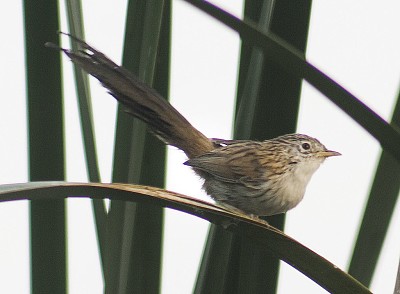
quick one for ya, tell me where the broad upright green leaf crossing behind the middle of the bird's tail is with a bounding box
[106,0,170,293]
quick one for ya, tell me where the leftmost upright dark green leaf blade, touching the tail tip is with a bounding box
[24,0,67,293]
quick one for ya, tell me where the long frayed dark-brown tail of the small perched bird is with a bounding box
[46,34,214,158]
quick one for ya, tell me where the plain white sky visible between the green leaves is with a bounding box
[0,0,400,293]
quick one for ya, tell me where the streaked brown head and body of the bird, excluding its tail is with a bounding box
[185,134,339,216]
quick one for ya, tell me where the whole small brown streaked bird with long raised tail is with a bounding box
[46,33,341,218]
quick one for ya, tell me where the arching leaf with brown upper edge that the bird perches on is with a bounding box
[0,182,371,293]
